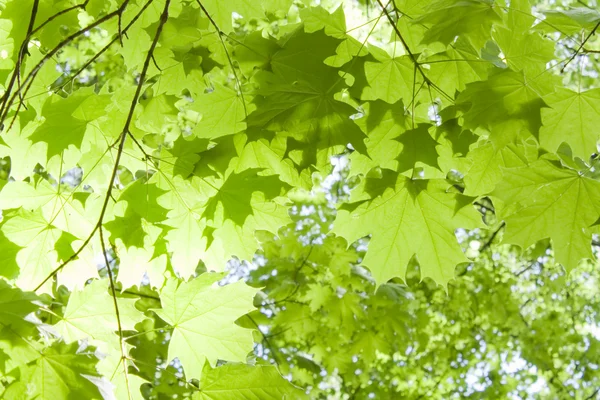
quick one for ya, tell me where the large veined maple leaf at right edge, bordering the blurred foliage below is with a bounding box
[493,160,600,270]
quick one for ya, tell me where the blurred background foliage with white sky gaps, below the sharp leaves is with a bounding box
[244,196,600,399]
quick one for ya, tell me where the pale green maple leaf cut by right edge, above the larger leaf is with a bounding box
[540,88,600,160]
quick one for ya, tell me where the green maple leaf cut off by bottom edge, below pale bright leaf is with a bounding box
[192,363,307,400]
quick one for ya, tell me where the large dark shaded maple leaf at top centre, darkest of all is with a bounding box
[248,30,366,168]
